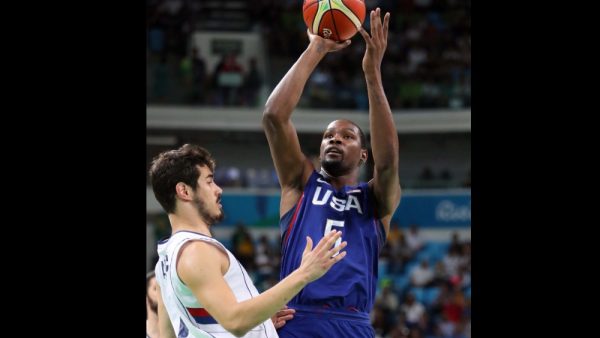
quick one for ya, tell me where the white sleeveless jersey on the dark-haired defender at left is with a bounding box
[155,231,279,338]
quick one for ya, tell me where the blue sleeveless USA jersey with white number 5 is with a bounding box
[280,171,385,316]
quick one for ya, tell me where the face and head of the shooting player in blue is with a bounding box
[320,120,366,176]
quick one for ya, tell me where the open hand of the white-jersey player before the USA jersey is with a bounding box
[298,230,348,282]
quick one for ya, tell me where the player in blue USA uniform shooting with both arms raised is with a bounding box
[263,8,400,338]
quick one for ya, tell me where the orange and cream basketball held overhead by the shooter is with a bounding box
[302,0,366,42]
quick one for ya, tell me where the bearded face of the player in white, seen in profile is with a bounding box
[194,166,225,224]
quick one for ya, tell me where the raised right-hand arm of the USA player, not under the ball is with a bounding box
[360,8,400,234]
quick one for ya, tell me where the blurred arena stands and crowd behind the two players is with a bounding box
[146,0,471,337]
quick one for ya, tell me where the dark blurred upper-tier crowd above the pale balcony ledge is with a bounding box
[147,0,471,110]
